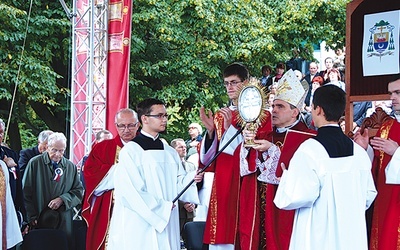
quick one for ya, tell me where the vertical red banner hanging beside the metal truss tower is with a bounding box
[106,0,132,135]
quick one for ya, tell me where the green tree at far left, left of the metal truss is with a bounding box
[0,0,71,150]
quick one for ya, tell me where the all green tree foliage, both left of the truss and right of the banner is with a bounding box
[0,0,348,149]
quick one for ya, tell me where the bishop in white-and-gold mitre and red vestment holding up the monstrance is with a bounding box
[244,70,316,250]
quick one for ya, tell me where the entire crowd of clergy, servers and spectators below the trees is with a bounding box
[0,55,400,250]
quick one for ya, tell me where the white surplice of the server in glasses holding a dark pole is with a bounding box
[107,142,199,250]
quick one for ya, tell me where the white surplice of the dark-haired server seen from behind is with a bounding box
[274,139,377,250]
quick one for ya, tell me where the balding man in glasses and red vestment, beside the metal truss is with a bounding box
[82,109,139,249]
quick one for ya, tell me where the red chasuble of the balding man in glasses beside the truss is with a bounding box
[82,135,123,250]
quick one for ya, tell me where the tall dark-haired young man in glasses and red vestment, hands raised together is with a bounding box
[200,63,271,250]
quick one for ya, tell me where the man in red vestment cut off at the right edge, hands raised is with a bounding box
[354,79,400,250]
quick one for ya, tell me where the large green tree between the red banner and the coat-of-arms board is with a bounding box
[126,0,348,143]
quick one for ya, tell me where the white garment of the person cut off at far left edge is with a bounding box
[0,160,22,249]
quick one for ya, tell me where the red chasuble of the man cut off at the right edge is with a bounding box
[370,119,400,250]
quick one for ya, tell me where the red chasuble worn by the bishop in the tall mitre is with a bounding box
[261,122,315,250]
